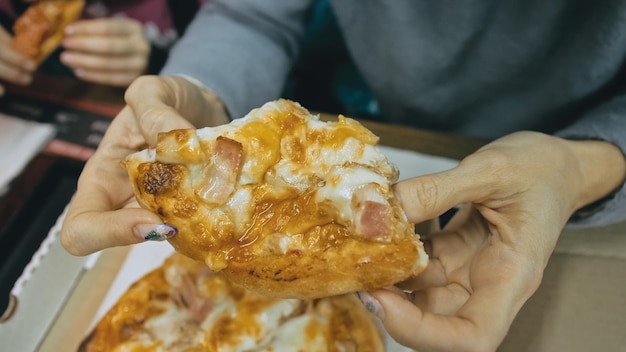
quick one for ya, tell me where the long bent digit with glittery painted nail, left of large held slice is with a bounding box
[61,107,178,255]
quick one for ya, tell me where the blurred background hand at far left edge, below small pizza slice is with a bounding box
[0,26,36,95]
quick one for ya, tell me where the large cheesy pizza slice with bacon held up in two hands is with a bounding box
[122,100,427,298]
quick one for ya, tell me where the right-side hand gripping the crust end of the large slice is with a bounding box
[360,132,626,351]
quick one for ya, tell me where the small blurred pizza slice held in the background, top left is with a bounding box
[12,0,85,64]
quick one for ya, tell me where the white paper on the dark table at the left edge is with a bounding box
[0,113,55,196]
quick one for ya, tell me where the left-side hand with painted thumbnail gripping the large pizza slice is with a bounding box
[61,76,228,255]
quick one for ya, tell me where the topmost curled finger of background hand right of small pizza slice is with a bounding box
[65,18,143,37]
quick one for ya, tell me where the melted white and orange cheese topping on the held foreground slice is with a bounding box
[127,101,397,253]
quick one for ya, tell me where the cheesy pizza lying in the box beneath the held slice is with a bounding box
[79,254,384,352]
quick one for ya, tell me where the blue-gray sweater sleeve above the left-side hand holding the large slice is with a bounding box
[161,0,312,118]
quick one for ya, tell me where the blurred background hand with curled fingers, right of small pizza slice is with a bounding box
[61,18,150,87]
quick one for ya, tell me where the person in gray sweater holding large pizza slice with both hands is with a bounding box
[62,0,626,351]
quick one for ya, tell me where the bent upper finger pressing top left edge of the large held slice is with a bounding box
[124,76,194,145]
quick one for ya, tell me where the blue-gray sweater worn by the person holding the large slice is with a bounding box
[162,0,626,226]
